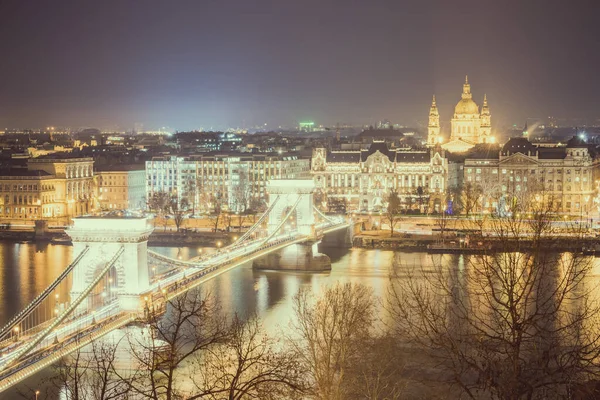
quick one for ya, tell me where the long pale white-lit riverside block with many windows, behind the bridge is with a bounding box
[146,153,310,211]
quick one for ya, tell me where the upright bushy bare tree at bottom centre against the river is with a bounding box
[288,283,375,400]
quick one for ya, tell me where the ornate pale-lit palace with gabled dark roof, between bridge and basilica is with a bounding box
[311,140,448,211]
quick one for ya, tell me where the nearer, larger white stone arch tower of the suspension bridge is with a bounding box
[67,217,153,311]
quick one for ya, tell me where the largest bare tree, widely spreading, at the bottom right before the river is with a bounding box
[389,211,600,400]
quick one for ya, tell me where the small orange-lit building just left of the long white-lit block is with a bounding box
[95,165,146,211]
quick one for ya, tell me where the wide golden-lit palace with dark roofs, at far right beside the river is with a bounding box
[464,137,598,216]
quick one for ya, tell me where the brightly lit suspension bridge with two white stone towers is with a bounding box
[0,179,352,392]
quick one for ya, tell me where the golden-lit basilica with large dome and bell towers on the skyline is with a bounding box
[434,78,494,153]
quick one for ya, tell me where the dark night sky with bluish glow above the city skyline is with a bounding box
[0,0,600,130]
